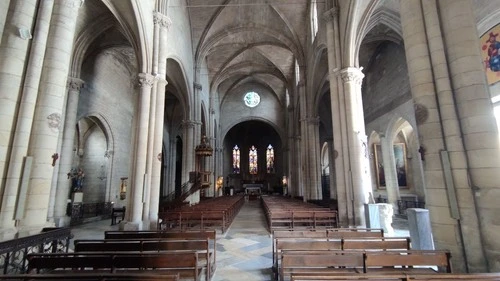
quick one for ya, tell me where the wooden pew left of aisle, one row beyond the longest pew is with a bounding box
[74,238,215,281]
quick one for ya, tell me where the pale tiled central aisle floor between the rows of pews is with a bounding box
[212,200,272,281]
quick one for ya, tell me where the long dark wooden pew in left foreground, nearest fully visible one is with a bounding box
[27,252,202,281]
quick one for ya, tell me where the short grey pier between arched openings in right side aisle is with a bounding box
[379,134,400,210]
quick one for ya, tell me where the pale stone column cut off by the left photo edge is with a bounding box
[0,0,37,208]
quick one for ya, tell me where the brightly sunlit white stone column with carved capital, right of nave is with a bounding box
[340,67,371,225]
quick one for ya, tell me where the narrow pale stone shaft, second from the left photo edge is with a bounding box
[0,0,54,232]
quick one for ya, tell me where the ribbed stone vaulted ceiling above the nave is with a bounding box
[187,0,309,104]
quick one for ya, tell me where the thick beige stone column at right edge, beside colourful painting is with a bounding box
[437,0,500,272]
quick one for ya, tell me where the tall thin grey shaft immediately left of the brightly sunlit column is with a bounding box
[323,7,354,226]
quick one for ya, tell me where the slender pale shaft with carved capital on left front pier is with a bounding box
[127,73,155,229]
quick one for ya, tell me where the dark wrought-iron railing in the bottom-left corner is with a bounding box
[0,228,73,274]
